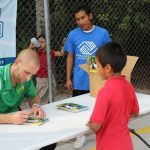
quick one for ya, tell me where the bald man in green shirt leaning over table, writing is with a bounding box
[0,49,45,124]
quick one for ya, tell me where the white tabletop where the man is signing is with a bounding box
[0,94,150,150]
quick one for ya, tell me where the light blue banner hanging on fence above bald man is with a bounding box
[0,0,17,65]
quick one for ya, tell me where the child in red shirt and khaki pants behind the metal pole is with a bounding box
[36,34,65,104]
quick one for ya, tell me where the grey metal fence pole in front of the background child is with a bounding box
[44,0,52,103]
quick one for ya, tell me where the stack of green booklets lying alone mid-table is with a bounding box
[56,103,88,112]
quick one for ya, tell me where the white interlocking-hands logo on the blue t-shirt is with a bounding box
[78,41,97,55]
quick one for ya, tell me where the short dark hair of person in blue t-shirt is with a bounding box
[73,4,92,15]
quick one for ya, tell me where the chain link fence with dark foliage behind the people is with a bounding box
[17,0,150,99]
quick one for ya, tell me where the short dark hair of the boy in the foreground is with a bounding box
[96,42,127,73]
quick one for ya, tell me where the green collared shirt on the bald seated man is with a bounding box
[0,64,36,113]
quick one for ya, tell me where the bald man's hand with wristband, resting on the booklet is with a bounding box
[30,104,45,118]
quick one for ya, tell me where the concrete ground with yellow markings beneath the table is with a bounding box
[56,114,150,150]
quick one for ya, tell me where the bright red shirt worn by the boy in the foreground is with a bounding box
[90,76,139,150]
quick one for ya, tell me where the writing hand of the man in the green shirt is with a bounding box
[12,111,29,124]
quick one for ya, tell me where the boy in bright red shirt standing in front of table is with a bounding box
[87,42,139,150]
